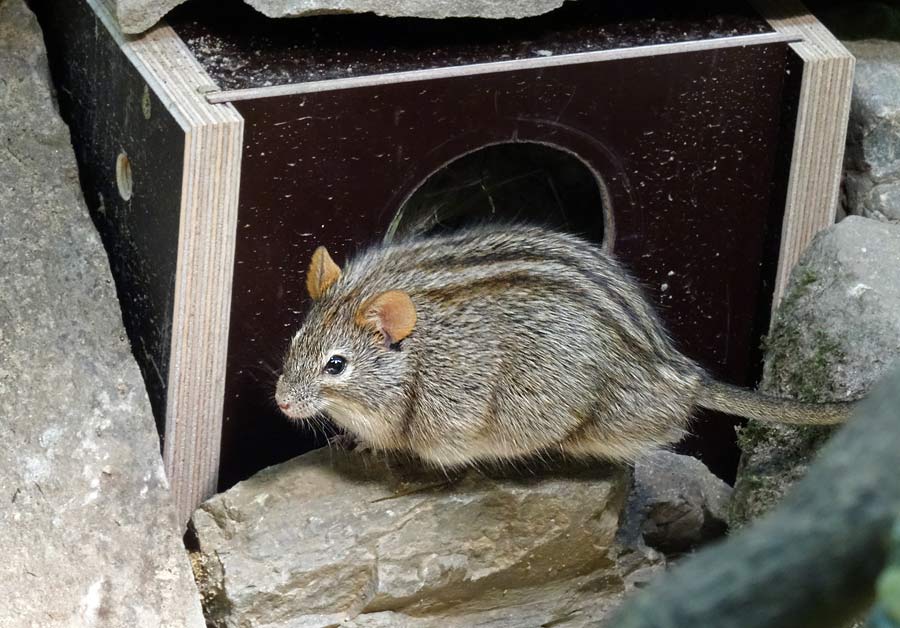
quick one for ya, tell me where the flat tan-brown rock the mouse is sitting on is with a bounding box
[192,450,654,628]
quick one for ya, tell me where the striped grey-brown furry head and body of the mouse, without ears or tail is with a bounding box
[276,227,702,466]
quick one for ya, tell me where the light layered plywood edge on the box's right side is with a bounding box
[754,0,856,308]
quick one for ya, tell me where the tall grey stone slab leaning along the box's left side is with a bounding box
[0,0,204,628]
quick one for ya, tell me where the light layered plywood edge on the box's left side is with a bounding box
[87,0,244,524]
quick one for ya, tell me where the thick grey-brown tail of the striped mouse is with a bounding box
[697,379,856,425]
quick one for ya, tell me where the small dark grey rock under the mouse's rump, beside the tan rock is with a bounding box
[623,451,731,554]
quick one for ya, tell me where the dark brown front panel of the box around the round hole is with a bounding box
[221,44,794,488]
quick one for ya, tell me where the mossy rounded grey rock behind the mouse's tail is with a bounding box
[731,216,900,525]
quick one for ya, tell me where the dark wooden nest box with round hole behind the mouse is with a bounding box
[43,0,853,521]
